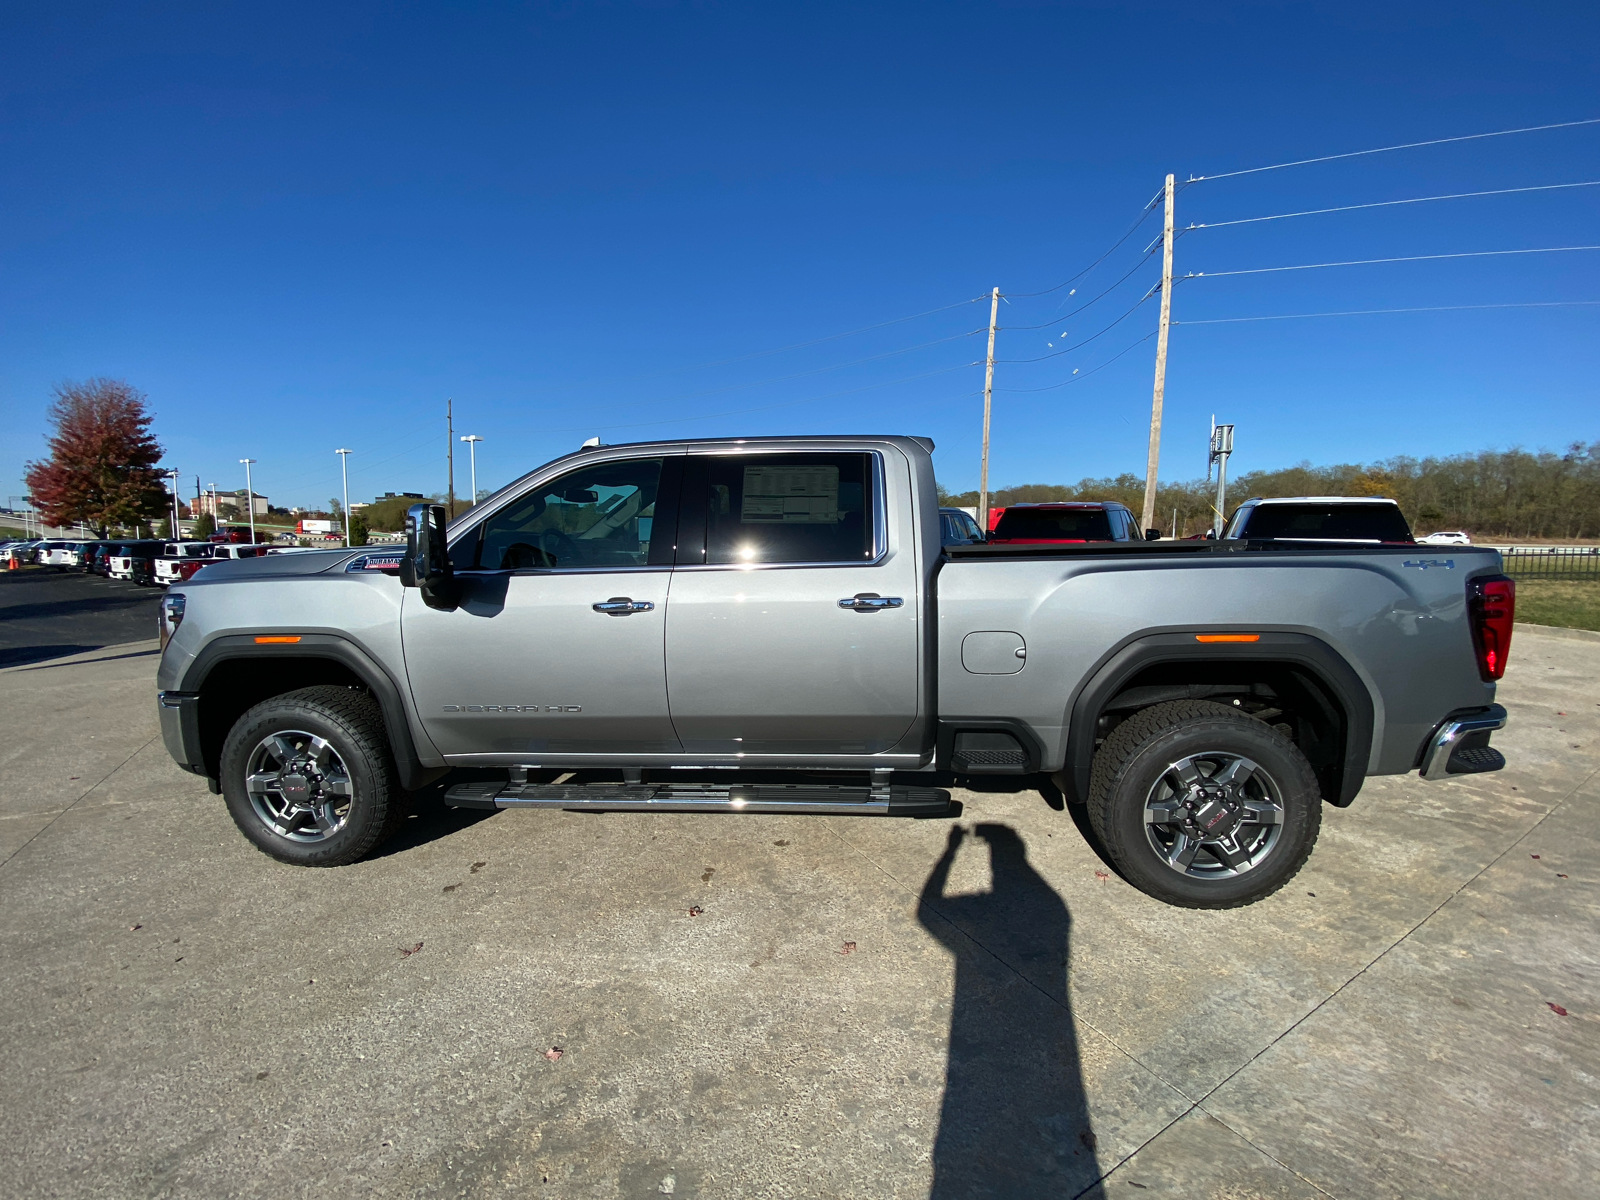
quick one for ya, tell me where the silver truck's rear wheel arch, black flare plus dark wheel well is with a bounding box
[1058,627,1374,808]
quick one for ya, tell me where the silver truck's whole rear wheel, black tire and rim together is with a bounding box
[1088,701,1322,909]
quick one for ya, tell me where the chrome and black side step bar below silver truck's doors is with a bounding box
[445,782,950,816]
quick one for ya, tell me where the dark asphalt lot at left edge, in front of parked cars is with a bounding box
[0,566,162,667]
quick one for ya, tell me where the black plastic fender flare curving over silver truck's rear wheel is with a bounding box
[1061,626,1376,808]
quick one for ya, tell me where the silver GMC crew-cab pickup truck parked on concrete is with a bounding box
[158,437,1514,907]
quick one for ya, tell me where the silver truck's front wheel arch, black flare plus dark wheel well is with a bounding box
[179,634,448,790]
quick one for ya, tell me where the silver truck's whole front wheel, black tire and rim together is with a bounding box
[222,685,405,867]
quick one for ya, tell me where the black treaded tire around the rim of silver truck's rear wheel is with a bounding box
[1088,701,1322,909]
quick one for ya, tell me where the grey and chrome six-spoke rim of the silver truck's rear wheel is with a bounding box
[1144,750,1283,880]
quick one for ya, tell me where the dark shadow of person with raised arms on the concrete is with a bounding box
[917,824,1104,1200]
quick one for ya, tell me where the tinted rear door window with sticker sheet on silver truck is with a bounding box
[678,453,877,565]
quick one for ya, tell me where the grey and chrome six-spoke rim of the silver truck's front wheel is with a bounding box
[245,730,355,842]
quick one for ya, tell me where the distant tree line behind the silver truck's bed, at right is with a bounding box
[939,442,1600,538]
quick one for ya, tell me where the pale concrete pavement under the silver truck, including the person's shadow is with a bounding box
[0,632,1600,1200]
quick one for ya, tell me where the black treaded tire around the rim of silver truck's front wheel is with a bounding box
[221,685,406,867]
